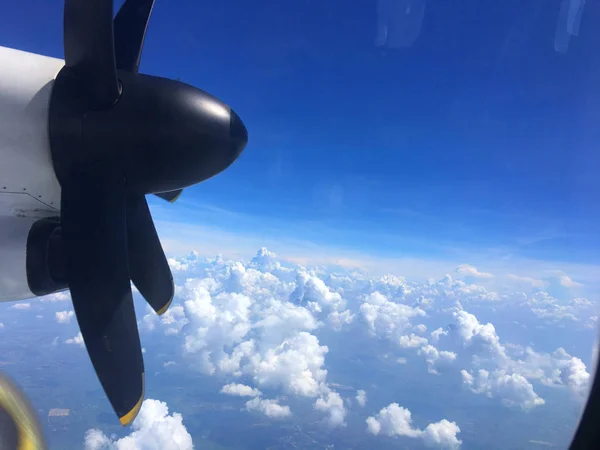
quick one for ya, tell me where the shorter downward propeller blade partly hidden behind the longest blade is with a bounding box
[127,195,175,315]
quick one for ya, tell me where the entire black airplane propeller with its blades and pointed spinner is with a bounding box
[49,0,248,425]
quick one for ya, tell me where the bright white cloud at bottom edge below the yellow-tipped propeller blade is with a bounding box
[85,399,194,450]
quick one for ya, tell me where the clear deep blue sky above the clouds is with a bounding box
[0,0,600,263]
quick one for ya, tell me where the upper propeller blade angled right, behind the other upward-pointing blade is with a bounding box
[114,0,154,72]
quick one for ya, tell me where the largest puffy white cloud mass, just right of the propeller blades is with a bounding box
[140,253,342,424]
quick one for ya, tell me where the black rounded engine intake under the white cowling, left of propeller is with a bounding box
[26,217,68,296]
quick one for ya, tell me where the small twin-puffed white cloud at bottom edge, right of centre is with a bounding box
[366,403,462,449]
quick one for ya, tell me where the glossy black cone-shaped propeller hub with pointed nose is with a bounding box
[50,69,248,194]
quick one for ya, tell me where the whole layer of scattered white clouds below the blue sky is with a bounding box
[52,248,596,449]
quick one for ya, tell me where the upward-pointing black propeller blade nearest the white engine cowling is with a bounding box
[63,0,121,108]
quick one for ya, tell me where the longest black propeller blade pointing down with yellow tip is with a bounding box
[61,170,144,425]
